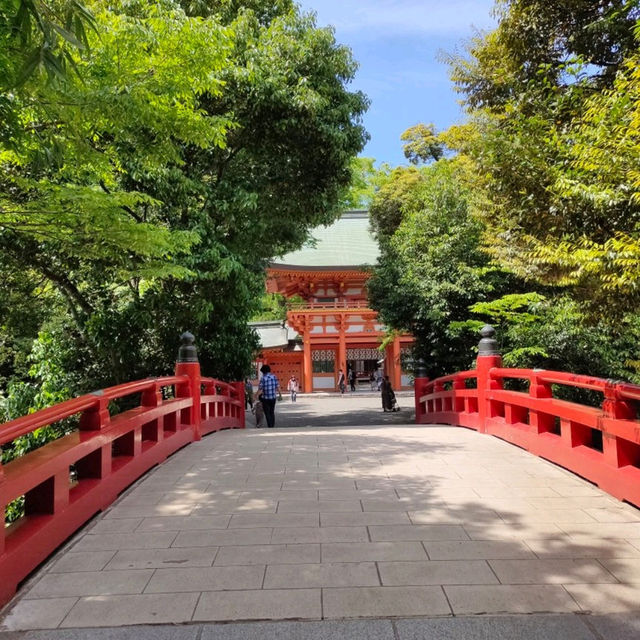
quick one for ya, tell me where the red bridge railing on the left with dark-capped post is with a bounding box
[0,334,244,604]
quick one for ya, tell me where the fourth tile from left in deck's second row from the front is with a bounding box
[378,560,498,586]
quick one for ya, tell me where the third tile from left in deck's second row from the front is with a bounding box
[264,562,380,589]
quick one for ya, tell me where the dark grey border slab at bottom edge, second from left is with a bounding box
[200,620,396,640]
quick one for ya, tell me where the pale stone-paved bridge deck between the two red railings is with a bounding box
[3,400,640,637]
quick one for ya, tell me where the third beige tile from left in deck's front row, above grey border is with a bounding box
[193,589,322,621]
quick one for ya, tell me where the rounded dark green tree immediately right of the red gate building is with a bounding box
[369,160,515,376]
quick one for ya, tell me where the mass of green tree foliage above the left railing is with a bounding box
[0,0,367,420]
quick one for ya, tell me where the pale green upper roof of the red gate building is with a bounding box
[272,211,379,269]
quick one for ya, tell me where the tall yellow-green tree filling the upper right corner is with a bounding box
[444,0,640,317]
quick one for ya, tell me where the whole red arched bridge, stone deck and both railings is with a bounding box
[0,327,640,638]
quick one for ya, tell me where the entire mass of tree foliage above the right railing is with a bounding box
[371,0,640,381]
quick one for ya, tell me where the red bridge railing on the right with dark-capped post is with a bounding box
[415,327,640,507]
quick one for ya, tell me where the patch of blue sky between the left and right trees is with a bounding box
[298,0,494,165]
